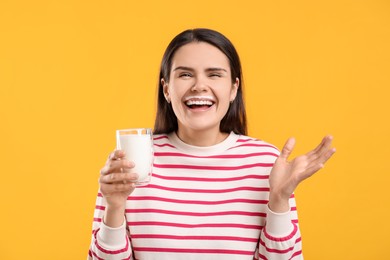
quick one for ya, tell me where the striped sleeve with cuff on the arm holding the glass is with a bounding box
[88,193,133,260]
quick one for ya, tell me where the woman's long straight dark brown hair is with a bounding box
[154,28,247,135]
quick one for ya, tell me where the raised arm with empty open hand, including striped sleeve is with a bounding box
[259,136,336,259]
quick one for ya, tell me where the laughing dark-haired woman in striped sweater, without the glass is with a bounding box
[89,29,335,260]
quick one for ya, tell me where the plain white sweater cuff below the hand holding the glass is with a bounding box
[97,217,126,249]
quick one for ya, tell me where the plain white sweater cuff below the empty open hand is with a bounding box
[266,205,294,237]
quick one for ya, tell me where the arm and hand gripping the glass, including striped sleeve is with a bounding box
[88,151,137,259]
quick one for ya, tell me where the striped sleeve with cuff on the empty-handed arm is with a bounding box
[256,195,303,260]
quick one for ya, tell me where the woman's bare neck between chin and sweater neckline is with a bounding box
[177,127,229,146]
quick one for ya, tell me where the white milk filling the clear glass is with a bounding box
[118,134,153,182]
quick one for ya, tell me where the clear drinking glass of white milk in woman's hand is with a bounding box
[116,128,153,185]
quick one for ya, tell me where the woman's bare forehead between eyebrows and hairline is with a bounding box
[171,42,230,70]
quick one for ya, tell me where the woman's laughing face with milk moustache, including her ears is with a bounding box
[162,42,239,135]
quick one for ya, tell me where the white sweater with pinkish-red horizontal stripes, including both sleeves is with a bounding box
[88,133,303,260]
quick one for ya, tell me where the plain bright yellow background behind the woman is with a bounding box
[0,0,390,260]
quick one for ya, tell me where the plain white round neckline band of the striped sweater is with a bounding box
[168,132,239,156]
